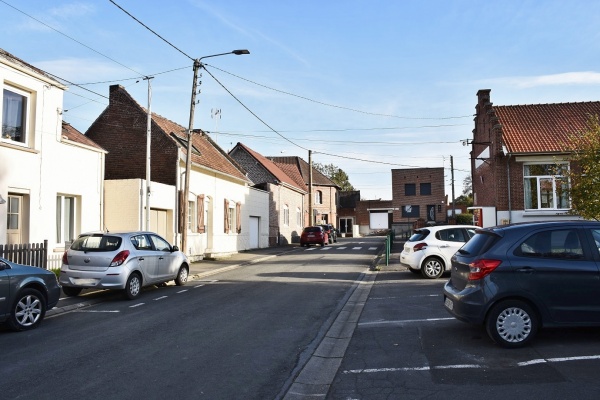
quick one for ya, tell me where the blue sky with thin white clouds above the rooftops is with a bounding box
[0,0,600,200]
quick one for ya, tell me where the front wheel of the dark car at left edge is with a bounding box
[8,289,46,331]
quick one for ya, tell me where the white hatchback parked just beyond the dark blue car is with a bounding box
[400,225,479,279]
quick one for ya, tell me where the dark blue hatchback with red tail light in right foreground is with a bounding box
[444,221,600,347]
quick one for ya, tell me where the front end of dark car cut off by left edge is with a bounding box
[0,258,60,331]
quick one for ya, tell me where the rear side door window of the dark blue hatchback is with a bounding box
[516,229,583,259]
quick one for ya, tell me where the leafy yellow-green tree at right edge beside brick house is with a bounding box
[561,115,600,220]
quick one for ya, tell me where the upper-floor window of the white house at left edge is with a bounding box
[2,88,29,143]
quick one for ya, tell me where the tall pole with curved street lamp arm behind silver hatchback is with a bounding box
[180,49,250,254]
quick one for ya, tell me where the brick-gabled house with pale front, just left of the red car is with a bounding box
[229,143,308,246]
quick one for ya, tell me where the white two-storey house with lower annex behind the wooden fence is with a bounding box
[0,49,106,253]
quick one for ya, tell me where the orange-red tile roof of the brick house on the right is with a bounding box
[493,101,600,154]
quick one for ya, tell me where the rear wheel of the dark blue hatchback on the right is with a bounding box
[485,300,539,348]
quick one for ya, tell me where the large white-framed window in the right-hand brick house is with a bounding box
[523,163,570,210]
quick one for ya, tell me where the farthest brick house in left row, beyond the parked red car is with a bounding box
[267,157,340,228]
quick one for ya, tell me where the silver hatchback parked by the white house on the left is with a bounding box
[59,232,189,300]
